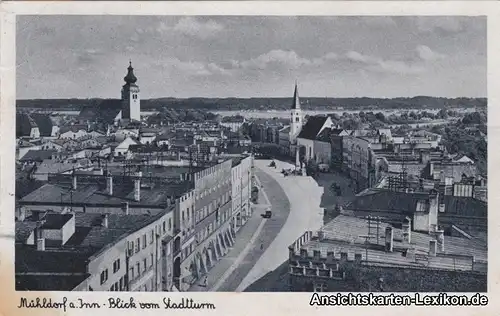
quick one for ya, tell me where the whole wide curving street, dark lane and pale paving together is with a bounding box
[190,160,354,292]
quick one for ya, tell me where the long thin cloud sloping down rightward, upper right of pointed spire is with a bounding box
[345,51,425,75]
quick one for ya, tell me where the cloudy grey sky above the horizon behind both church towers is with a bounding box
[16,16,487,99]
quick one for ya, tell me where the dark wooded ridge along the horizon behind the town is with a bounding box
[16,96,487,111]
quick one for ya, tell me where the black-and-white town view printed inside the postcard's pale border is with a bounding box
[12,15,488,292]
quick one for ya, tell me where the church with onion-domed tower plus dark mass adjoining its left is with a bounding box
[78,62,141,125]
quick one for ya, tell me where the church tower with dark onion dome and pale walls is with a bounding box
[122,61,141,121]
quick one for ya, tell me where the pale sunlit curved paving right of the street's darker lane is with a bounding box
[236,160,323,292]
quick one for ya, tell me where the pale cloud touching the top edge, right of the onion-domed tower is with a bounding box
[156,16,224,39]
